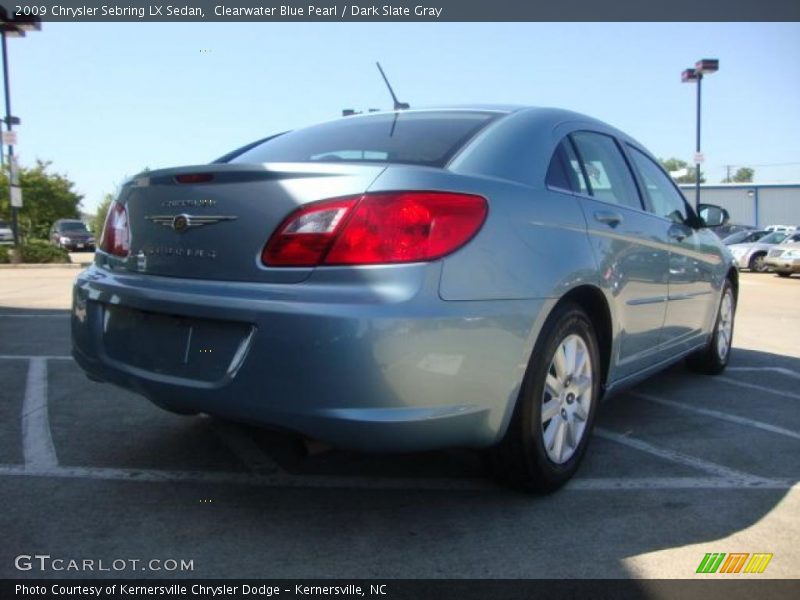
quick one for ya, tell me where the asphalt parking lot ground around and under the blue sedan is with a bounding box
[0,269,800,578]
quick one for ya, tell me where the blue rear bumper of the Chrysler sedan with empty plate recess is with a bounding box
[72,263,552,451]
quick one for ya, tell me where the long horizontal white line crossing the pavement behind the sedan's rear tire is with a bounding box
[0,465,800,491]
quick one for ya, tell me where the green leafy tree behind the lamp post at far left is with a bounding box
[0,161,82,244]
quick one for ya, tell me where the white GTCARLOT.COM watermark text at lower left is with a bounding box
[14,554,194,573]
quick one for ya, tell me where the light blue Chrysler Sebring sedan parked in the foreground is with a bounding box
[72,107,738,492]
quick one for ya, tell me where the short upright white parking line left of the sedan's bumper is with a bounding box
[22,358,58,468]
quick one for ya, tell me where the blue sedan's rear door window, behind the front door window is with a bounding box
[571,131,642,210]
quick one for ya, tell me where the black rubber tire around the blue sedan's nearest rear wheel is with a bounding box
[488,303,601,494]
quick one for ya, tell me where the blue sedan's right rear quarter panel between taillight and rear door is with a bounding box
[370,112,599,301]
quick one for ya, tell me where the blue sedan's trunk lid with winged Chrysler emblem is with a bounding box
[111,163,386,283]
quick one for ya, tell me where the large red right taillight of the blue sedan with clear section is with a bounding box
[261,192,487,267]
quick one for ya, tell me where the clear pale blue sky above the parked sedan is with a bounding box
[8,23,800,213]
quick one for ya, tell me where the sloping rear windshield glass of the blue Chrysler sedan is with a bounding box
[230,111,498,167]
